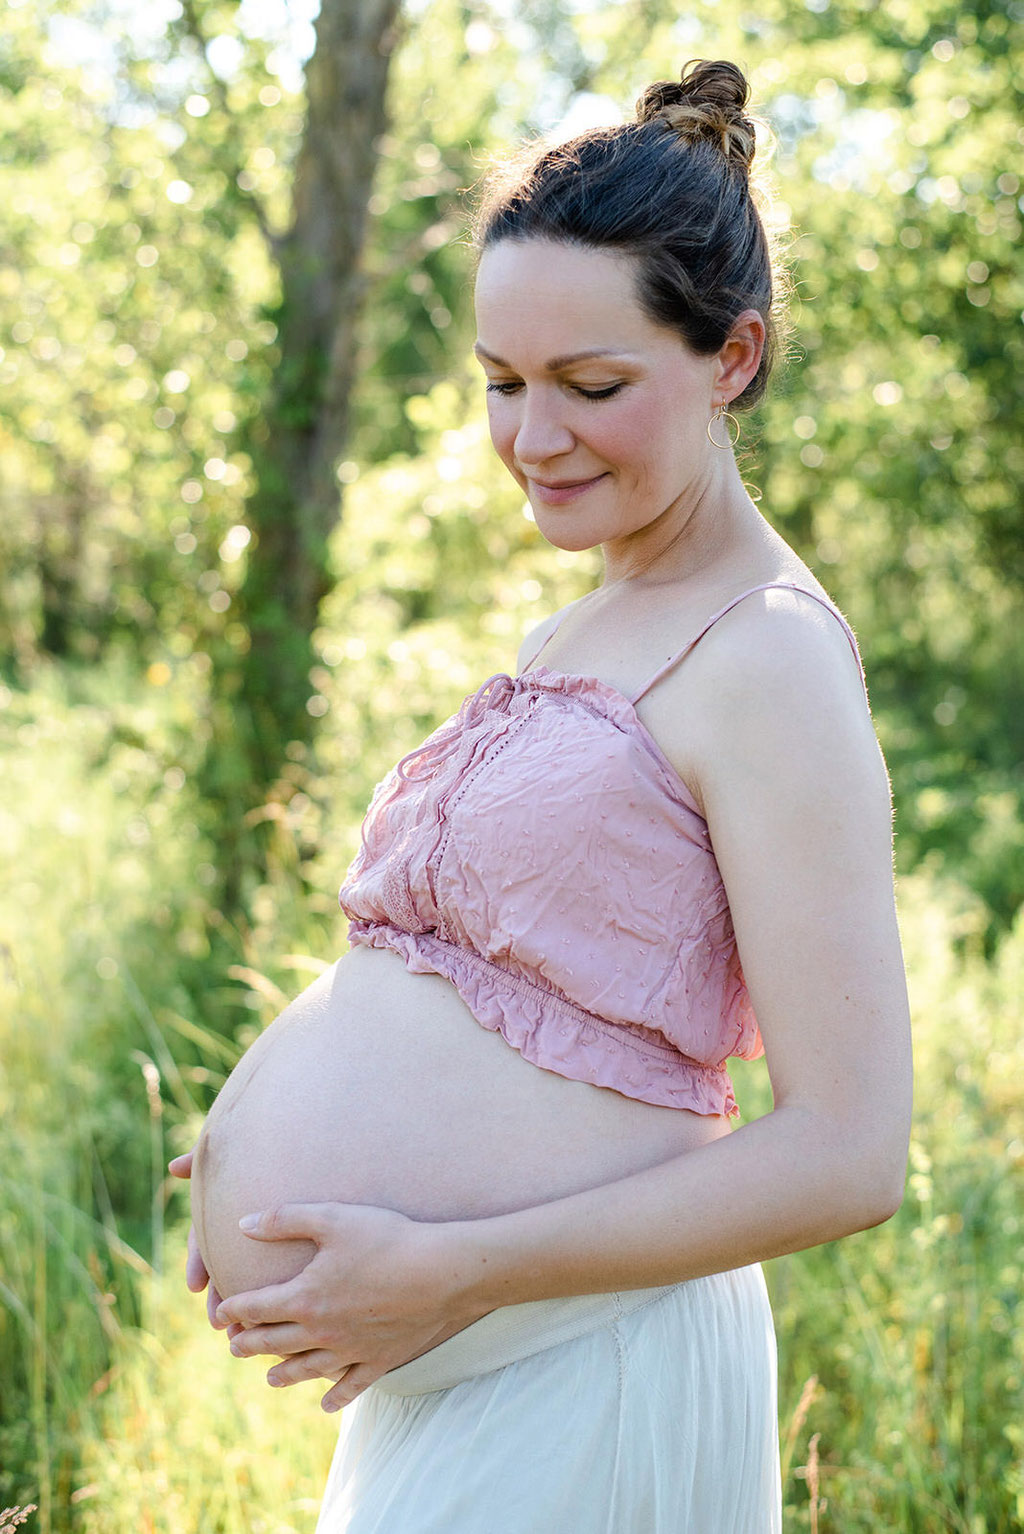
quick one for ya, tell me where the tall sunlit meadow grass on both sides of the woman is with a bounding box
[0,665,1024,1534]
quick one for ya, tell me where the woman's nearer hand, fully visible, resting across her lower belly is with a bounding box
[216,1204,484,1411]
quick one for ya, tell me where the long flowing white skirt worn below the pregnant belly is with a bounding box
[316,1266,782,1534]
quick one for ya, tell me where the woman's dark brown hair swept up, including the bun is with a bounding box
[474,60,777,405]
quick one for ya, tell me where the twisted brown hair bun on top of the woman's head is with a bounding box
[636,58,754,172]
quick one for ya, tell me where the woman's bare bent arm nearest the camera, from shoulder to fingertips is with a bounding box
[221,601,911,1404]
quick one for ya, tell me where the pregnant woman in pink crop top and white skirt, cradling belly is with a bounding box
[176,61,911,1534]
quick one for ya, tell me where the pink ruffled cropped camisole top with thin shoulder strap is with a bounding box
[340,581,863,1114]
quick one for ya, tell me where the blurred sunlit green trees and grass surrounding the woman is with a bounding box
[0,0,1024,1534]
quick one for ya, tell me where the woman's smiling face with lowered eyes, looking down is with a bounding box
[475,239,731,549]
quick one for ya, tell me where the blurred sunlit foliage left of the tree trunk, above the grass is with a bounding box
[0,5,283,669]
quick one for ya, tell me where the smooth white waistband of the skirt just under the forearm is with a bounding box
[373,1279,680,1396]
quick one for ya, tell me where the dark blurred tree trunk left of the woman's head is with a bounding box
[228,0,400,785]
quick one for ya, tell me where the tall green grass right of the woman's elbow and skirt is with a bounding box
[751,877,1024,1534]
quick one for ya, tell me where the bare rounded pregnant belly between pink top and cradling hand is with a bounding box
[192,948,728,1296]
